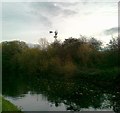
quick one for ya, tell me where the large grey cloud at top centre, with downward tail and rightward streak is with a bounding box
[29,2,77,27]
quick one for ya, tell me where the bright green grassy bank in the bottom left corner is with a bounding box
[0,97,20,111]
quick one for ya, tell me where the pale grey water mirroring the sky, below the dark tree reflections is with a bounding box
[6,92,113,111]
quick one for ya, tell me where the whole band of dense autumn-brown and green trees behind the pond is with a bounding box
[1,36,120,86]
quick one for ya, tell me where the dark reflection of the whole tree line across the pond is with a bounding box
[3,78,120,113]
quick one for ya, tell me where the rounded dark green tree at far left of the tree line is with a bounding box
[2,41,28,75]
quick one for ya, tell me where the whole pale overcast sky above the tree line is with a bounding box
[2,0,118,43]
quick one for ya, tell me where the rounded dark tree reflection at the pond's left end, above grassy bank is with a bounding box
[2,75,29,97]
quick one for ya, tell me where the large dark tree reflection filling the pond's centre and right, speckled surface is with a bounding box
[27,80,112,111]
